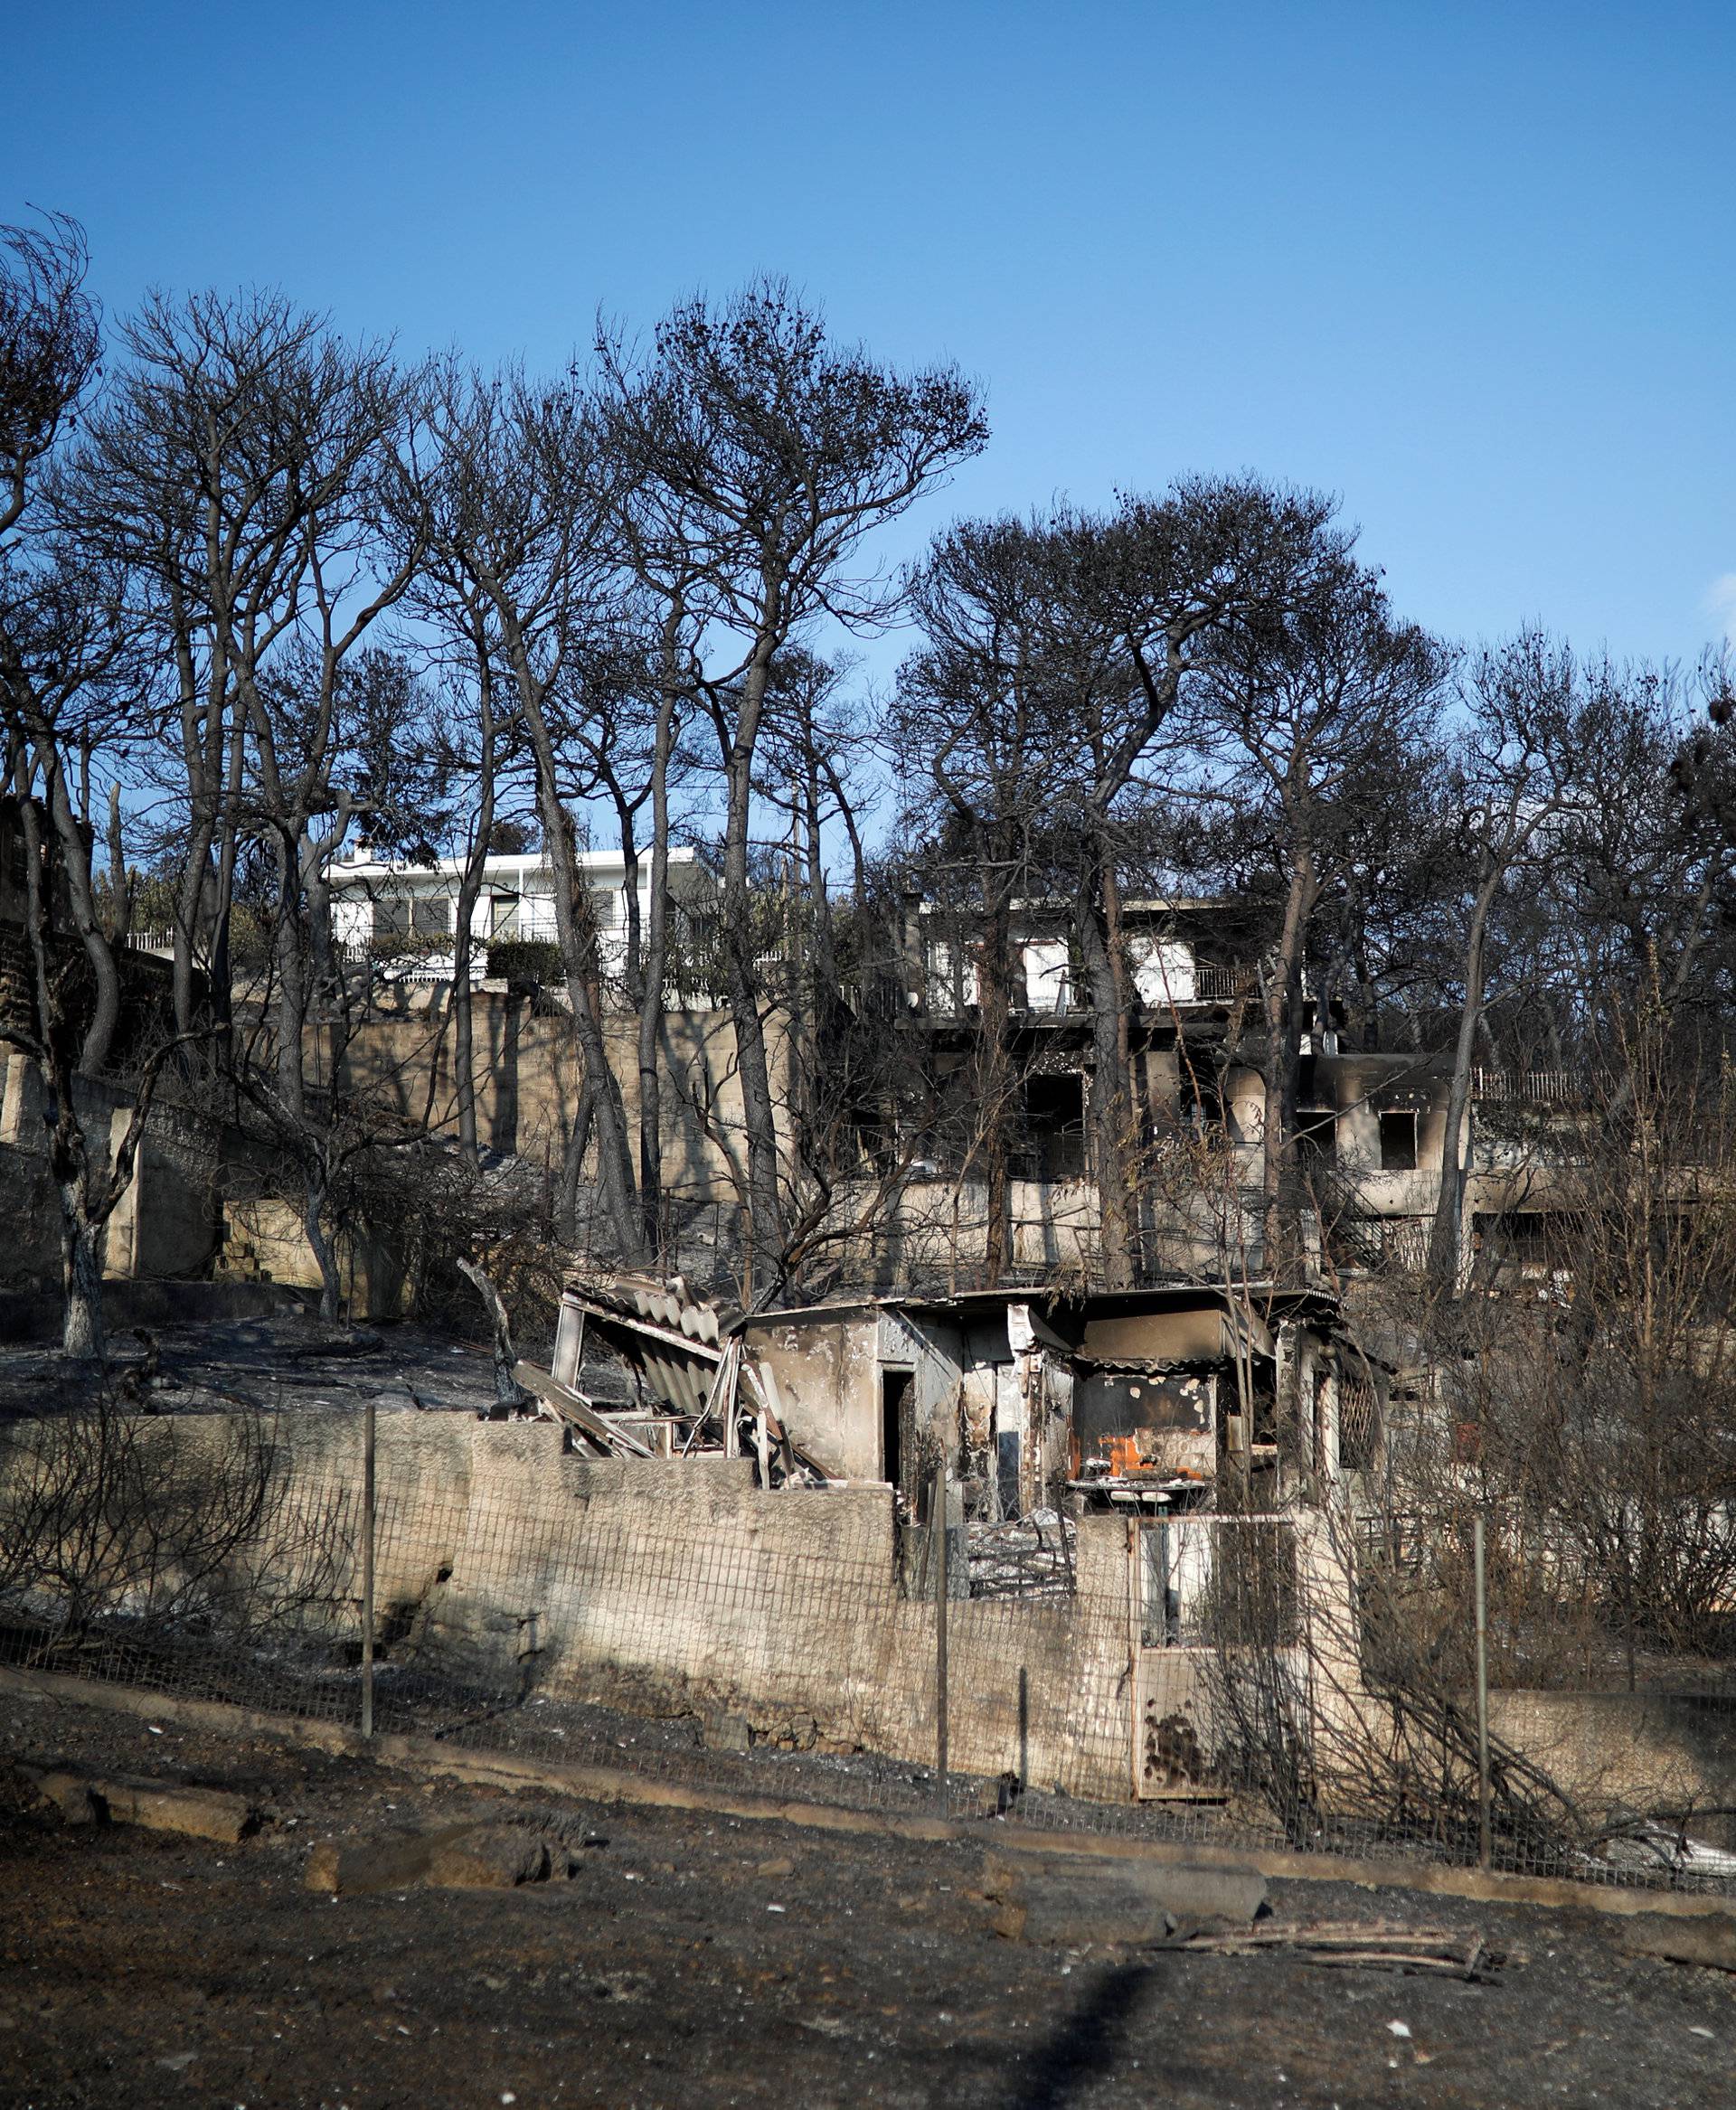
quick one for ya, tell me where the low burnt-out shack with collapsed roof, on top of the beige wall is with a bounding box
[555,1276,1383,1521]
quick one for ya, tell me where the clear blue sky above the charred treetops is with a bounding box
[0,0,1736,658]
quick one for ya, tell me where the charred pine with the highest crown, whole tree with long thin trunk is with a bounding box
[599,280,987,1300]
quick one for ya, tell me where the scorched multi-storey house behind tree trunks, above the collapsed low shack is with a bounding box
[865,895,1573,1287]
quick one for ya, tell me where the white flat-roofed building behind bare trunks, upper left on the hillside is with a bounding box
[331,851,711,981]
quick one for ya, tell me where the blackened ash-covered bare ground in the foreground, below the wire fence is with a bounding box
[0,1694,1736,2110]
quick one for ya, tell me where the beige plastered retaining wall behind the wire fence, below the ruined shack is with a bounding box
[3,1411,1133,1800]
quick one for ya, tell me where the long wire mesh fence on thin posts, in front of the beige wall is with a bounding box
[0,1424,1736,1890]
